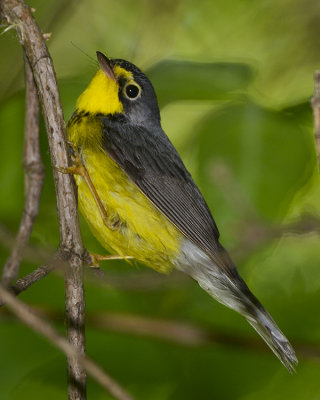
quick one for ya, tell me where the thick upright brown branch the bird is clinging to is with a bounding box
[0,0,86,400]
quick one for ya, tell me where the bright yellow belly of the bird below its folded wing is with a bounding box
[75,147,183,272]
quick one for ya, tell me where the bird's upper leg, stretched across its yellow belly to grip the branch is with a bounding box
[55,141,119,230]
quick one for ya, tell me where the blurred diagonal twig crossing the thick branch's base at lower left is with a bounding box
[0,285,133,400]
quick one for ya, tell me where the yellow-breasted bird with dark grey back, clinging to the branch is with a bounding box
[65,52,297,371]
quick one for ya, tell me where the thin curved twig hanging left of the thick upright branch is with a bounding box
[2,52,44,286]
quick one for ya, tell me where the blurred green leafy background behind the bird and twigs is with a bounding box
[0,0,320,400]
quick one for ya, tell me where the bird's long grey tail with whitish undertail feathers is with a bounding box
[177,241,298,373]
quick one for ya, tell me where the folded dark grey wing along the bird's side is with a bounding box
[101,117,220,264]
